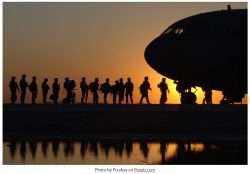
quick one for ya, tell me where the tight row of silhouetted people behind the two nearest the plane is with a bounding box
[9,74,138,104]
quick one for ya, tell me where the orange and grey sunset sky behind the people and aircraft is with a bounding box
[3,2,247,103]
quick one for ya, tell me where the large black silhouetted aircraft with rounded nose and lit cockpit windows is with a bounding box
[145,6,247,103]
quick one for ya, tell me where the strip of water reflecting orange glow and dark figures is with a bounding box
[3,140,247,164]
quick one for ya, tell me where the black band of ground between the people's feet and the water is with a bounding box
[3,104,247,140]
